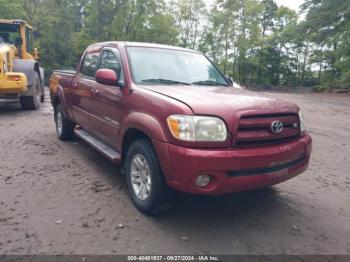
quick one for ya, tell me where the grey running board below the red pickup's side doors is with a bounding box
[74,126,121,163]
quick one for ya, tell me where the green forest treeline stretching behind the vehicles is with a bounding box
[0,0,350,89]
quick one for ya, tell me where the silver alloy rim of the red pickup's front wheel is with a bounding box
[130,154,152,200]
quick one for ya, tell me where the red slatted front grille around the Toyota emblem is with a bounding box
[235,114,300,146]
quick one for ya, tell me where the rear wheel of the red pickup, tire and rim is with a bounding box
[55,105,75,141]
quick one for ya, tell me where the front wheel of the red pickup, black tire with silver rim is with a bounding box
[125,139,174,216]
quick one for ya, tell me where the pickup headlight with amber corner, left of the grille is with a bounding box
[168,115,227,142]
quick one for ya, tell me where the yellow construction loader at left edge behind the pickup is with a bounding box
[0,19,45,110]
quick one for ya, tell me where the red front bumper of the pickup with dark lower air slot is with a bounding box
[153,134,312,195]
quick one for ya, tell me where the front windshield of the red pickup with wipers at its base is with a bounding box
[127,47,228,86]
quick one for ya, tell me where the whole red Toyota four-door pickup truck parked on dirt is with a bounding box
[50,42,312,214]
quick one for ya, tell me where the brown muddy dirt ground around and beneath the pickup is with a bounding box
[0,93,350,255]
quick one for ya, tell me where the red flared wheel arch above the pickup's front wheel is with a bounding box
[120,112,167,142]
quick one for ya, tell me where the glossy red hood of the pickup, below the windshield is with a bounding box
[138,85,299,115]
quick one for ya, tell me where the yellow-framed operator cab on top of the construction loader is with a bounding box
[0,20,39,60]
